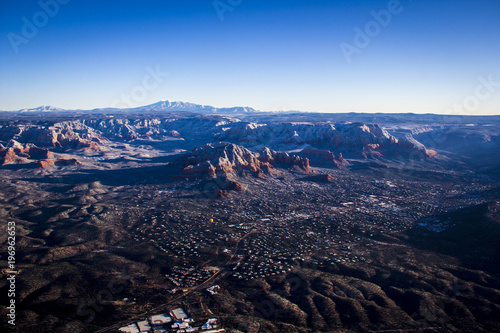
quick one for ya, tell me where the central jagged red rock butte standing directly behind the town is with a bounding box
[183,142,313,178]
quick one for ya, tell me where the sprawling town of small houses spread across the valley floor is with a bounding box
[127,175,494,288]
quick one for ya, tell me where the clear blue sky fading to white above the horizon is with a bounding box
[0,0,500,114]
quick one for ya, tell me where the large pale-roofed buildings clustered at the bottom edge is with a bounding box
[119,308,225,333]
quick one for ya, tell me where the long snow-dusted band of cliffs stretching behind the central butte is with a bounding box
[0,115,434,160]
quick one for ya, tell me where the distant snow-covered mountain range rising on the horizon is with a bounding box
[13,100,260,114]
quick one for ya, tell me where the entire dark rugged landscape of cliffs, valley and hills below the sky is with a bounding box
[0,104,500,332]
